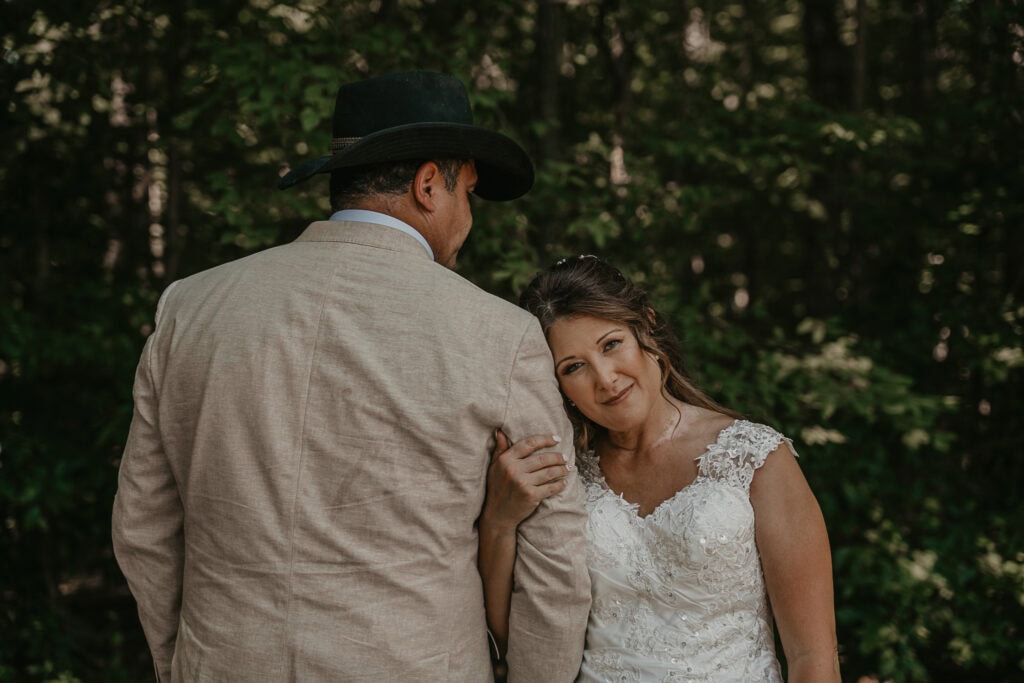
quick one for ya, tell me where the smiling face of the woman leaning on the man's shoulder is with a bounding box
[548,315,662,432]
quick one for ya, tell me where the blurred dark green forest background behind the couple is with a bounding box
[0,0,1024,682]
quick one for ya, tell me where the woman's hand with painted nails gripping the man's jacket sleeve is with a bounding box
[483,429,569,533]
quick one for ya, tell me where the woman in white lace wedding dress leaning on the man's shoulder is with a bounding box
[480,256,840,683]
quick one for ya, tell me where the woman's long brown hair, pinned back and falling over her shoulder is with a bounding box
[519,255,739,450]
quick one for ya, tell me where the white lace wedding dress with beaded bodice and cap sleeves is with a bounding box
[577,420,792,683]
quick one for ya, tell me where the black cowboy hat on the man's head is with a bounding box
[278,72,534,201]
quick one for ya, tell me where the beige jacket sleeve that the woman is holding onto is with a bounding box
[504,319,591,683]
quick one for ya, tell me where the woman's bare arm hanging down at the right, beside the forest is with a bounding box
[751,445,841,683]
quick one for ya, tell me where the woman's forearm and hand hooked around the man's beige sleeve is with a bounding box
[477,430,568,656]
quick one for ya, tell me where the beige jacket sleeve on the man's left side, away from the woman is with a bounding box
[112,288,184,681]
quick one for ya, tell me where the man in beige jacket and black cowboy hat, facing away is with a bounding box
[113,73,590,682]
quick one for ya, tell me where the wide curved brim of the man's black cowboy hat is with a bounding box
[278,123,534,202]
